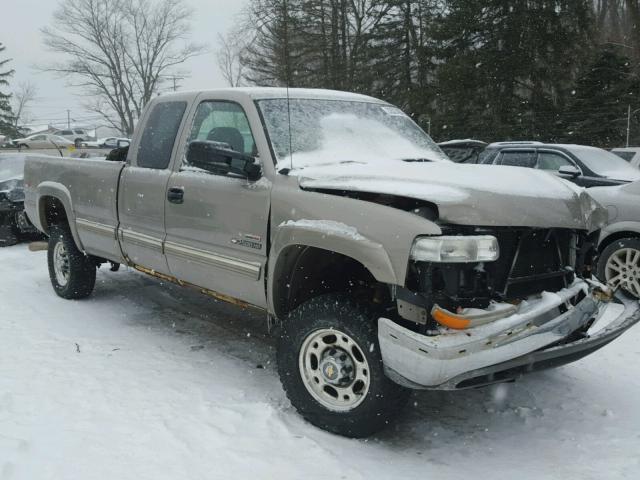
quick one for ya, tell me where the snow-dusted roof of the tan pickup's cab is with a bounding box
[162,87,388,105]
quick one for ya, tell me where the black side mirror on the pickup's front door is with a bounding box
[187,140,262,181]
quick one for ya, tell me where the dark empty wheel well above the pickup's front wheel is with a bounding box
[273,245,390,319]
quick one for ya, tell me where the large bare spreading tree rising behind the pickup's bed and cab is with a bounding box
[42,0,205,135]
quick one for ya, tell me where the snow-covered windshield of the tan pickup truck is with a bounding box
[258,99,448,168]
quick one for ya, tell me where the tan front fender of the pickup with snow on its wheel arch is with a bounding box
[268,178,442,312]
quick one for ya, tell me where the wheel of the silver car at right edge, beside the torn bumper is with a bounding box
[598,238,640,298]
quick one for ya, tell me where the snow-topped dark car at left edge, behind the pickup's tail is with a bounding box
[0,155,37,247]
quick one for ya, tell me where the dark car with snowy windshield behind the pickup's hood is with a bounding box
[472,142,640,187]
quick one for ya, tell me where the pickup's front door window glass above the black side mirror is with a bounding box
[189,101,257,156]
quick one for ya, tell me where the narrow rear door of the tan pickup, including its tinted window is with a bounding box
[118,99,187,274]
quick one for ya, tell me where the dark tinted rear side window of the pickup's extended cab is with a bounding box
[137,102,187,170]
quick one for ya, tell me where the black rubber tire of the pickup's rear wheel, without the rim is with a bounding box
[47,225,96,300]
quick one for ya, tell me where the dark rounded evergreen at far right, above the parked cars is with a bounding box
[564,46,640,148]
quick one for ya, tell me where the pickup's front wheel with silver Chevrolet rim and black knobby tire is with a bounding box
[277,295,409,438]
